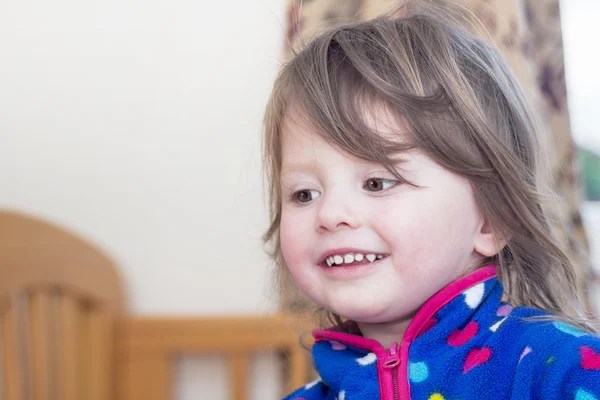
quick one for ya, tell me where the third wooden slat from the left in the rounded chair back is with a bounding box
[58,294,81,400]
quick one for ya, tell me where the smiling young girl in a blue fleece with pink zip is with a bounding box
[265,3,600,400]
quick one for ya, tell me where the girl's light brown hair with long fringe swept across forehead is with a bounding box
[264,3,595,331]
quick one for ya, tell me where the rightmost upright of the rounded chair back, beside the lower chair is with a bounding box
[81,310,114,400]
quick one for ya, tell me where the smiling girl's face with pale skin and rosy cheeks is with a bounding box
[280,114,490,323]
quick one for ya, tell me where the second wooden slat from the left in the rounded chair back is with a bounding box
[29,292,52,400]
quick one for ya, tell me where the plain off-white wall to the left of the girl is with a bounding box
[0,0,286,399]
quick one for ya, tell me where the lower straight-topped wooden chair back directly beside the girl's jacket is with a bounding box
[119,315,311,400]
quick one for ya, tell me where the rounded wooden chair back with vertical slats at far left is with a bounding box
[0,211,123,400]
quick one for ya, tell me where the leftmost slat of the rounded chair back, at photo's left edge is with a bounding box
[1,307,24,400]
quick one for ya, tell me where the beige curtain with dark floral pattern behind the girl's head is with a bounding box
[282,0,594,310]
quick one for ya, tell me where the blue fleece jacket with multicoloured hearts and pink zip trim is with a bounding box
[284,266,600,400]
